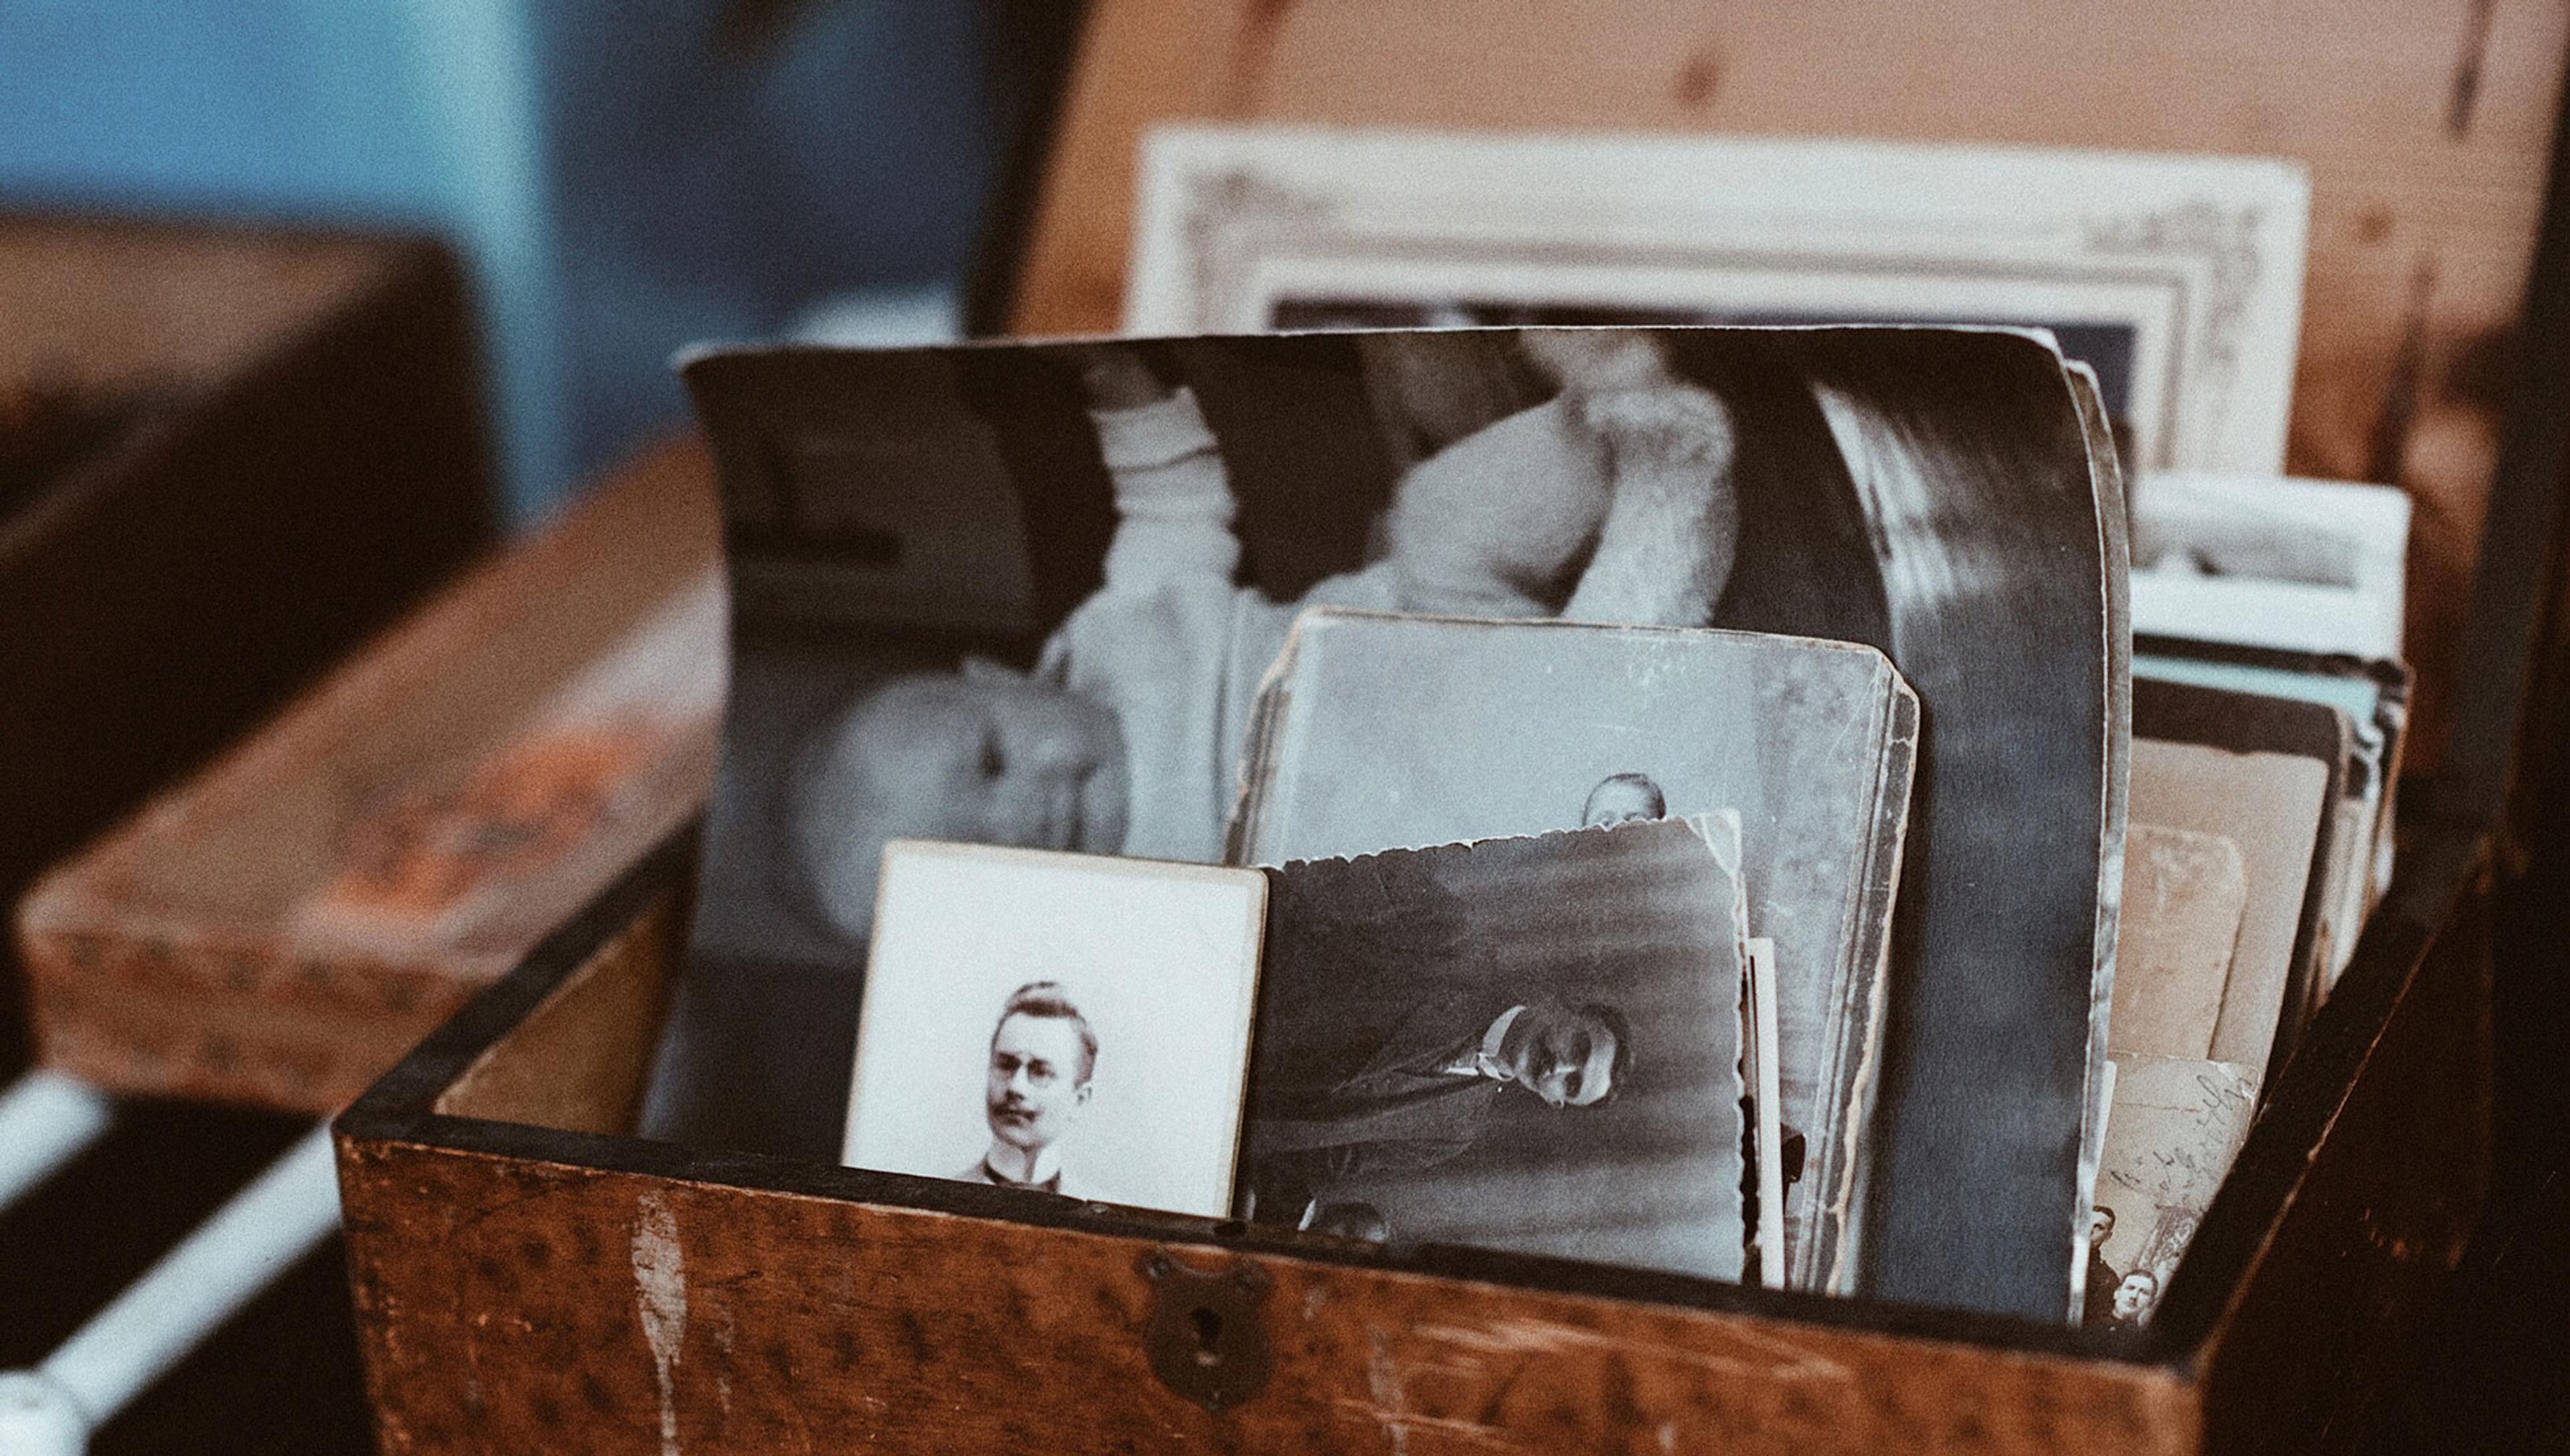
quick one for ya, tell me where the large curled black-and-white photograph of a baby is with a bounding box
[648,329,2128,1317]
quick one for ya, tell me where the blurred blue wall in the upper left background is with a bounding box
[0,0,997,516]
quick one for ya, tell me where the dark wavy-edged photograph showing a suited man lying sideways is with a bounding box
[1241,822,1743,1279]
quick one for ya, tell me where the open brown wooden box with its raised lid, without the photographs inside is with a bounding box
[337,0,2570,1456]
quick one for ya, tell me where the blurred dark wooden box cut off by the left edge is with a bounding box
[0,215,493,1066]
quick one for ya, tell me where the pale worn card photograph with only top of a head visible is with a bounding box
[1233,608,1919,1289]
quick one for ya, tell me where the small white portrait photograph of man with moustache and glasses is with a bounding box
[841,840,1267,1217]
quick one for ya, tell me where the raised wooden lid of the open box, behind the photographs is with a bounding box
[1015,0,2570,767]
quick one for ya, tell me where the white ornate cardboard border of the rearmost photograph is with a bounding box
[1123,123,2310,475]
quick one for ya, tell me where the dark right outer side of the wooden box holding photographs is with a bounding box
[2161,830,2493,1451]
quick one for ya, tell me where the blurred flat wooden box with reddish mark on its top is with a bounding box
[18,442,722,1112]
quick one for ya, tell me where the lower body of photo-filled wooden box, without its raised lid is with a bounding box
[337,816,2485,1453]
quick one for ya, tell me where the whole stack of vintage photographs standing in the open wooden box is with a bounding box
[645,128,2408,1325]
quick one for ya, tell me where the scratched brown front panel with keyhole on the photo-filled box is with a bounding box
[342,1143,2195,1456]
